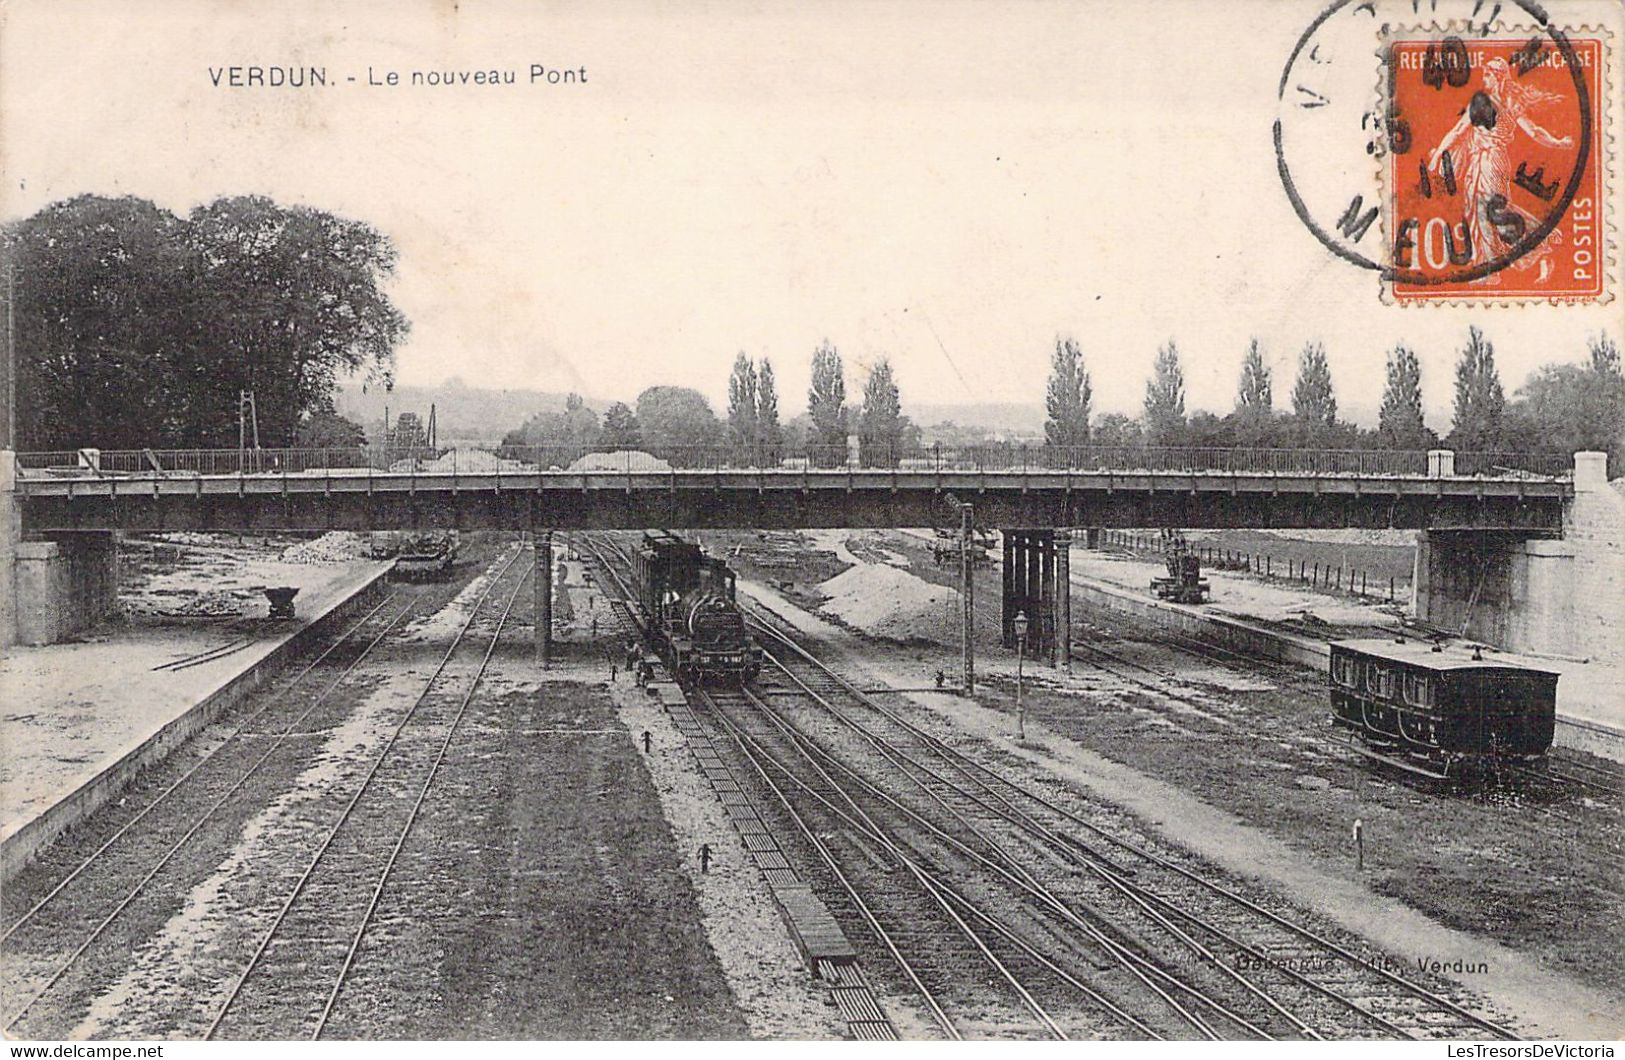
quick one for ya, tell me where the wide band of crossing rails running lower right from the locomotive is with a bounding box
[578,533,1513,1037]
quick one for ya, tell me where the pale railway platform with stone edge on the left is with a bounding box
[0,559,390,881]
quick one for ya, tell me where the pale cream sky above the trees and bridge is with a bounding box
[0,0,1625,428]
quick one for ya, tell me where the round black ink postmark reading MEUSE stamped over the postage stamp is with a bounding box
[1274,0,1602,294]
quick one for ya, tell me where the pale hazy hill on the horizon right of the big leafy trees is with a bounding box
[338,382,608,444]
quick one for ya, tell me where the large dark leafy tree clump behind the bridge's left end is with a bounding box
[3,195,408,449]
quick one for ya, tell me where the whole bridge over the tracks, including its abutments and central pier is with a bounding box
[0,445,1607,676]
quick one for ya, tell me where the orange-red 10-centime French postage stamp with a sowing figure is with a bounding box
[1383,26,1610,304]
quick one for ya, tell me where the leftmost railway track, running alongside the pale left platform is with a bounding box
[0,553,520,1036]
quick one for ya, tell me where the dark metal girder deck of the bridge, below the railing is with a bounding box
[15,463,1573,532]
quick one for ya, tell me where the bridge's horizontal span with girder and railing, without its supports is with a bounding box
[15,447,1573,535]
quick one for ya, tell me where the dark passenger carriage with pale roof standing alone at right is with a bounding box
[1329,641,1557,779]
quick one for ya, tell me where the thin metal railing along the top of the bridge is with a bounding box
[18,442,1571,478]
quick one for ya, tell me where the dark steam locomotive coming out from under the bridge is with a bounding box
[632,530,762,683]
